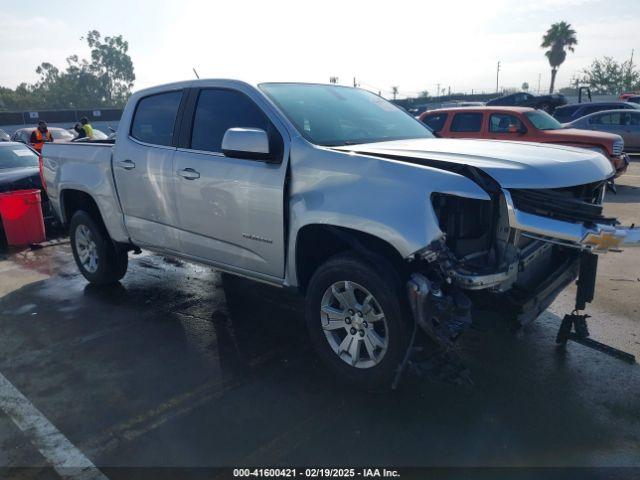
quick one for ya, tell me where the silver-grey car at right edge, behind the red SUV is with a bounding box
[564,110,640,152]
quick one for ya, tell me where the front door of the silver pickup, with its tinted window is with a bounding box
[174,87,288,278]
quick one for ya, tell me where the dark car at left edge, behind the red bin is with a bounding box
[0,142,52,243]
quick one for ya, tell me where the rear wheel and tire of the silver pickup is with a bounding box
[69,210,129,285]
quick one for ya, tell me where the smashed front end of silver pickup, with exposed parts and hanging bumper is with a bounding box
[408,181,640,348]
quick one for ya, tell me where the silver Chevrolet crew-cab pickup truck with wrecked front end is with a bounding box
[43,80,639,386]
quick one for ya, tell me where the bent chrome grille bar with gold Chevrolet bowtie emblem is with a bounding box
[502,190,640,253]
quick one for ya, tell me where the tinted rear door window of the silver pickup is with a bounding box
[131,91,182,146]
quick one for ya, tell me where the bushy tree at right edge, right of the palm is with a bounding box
[580,57,640,95]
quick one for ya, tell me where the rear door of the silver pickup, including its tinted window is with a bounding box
[113,90,183,250]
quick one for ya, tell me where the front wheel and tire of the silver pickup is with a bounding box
[306,253,408,390]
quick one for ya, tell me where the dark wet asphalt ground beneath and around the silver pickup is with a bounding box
[0,160,640,478]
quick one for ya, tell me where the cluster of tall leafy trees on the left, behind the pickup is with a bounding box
[0,30,135,110]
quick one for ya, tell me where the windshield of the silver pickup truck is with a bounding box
[260,83,434,146]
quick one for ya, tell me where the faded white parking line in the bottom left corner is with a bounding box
[0,373,108,480]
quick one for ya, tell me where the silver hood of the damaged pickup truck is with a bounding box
[335,138,614,188]
